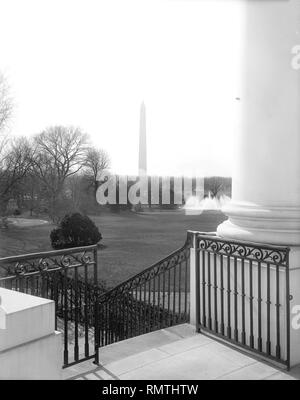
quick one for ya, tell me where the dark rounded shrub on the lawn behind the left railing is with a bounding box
[50,213,102,249]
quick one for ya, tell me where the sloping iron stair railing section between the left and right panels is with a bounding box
[98,240,190,347]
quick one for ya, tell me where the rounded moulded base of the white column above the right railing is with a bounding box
[217,202,300,246]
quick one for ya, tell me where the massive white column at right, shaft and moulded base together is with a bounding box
[218,0,300,245]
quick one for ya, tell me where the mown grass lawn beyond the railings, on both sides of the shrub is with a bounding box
[0,212,225,287]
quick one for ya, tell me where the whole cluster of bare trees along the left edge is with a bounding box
[0,75,110,222]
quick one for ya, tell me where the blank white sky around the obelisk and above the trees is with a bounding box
[0,0,239,175]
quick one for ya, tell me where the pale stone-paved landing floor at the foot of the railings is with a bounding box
[63,324,300,380]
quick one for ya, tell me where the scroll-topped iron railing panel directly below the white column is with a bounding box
[193,233,291,368]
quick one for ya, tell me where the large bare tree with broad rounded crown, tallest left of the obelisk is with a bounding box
[33,126,88,219]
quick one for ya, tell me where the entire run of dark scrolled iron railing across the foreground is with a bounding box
[0,232,290,367]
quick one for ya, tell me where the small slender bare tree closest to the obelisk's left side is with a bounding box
[85,148,110,201]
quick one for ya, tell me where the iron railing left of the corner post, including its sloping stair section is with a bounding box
[0,241,190,367]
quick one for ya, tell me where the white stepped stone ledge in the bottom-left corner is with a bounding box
[0,288,62,379]
